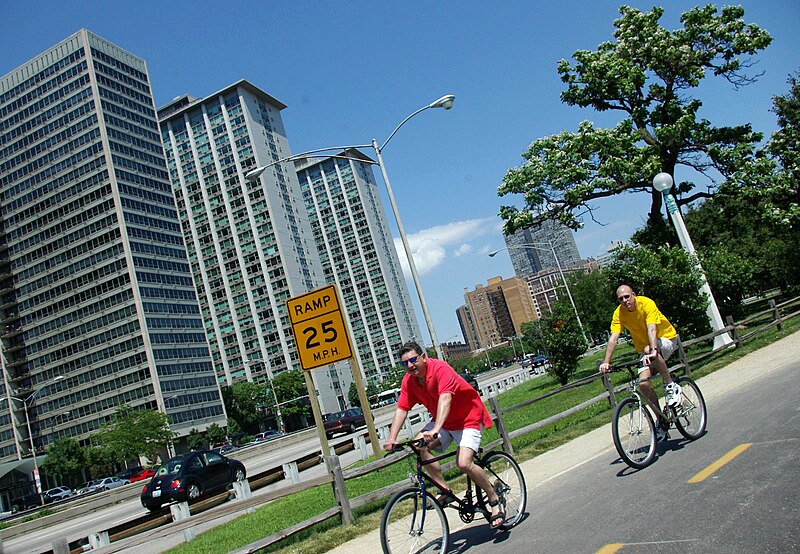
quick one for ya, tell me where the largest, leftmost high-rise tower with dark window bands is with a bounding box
[0,30,226,461]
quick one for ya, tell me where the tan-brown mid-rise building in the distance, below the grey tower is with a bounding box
[459,277,538,350]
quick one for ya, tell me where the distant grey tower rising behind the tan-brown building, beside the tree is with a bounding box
[505,220,581,278]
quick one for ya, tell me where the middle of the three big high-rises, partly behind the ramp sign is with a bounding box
[158,80,339,411]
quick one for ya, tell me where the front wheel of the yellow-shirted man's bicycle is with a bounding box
[611,398,656,469]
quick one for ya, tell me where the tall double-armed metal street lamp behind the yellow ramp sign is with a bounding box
[245,94,456,359]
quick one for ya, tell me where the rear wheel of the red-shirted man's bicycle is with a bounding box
[477,450,528,530]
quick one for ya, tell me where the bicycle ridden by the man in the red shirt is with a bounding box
[380,439,527,554]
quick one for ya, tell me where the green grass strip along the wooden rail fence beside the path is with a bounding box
[168,318,800,554]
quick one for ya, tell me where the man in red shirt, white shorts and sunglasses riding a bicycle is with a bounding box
[383,342,505,528]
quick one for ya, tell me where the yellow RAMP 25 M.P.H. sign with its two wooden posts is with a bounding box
[286,284,381,458]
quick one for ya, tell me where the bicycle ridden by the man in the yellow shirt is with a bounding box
[611,364,707,469]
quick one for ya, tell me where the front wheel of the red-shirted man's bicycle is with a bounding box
[381,487,450,554]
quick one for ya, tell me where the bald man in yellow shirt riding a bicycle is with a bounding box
[600,285,681,441]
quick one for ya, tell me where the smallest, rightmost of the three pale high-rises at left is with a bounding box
[295,149,421,388]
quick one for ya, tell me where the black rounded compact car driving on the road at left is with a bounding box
[141,450,247,512]
